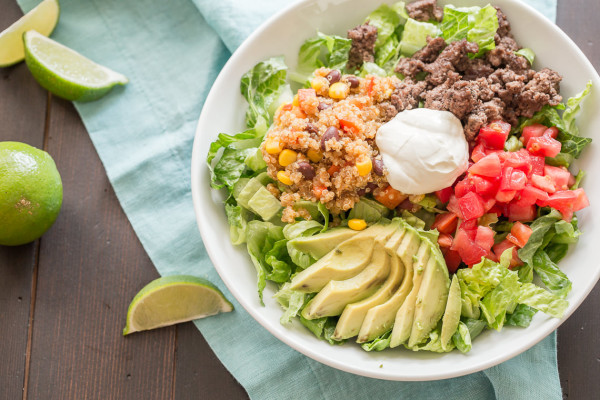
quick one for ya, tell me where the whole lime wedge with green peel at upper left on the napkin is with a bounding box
[23,31,129,101]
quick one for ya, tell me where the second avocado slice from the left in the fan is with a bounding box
[290,224,394,293]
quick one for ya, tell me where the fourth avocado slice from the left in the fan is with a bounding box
[332,233,404,340]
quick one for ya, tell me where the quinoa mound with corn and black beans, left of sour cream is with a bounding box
[261,68,400,222]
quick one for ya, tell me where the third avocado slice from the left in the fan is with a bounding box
[302,242,390,319]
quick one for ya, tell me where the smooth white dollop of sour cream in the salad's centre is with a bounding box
[375,108,469,194]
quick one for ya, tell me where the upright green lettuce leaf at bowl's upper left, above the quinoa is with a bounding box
[240,56,287,128]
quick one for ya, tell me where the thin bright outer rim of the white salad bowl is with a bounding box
[191,0,600,381]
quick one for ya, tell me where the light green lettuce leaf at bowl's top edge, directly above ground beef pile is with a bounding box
[440,5,498,58]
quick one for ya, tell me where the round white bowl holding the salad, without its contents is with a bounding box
[192,0,600,381]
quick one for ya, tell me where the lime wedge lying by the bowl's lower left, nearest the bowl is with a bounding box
[123,275,233,335]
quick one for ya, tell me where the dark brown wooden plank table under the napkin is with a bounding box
[0,0,600,399]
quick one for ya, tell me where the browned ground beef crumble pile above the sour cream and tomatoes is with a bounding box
[386,1,562,140]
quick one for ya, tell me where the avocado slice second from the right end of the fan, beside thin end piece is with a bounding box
[408,244,454,347]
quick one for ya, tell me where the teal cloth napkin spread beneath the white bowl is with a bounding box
[18,0,562,400]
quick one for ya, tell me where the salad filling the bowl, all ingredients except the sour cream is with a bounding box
[207,1,592,353]
